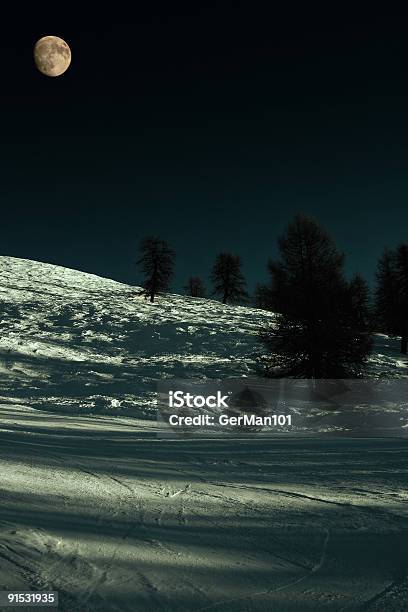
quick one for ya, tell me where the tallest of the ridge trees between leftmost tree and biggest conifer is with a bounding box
[211,253,248,304]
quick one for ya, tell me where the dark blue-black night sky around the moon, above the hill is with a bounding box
[0,1,408,290]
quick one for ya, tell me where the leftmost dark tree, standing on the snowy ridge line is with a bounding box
[137,236,175,302]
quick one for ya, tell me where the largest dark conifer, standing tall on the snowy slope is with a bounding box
[260,215,371,378]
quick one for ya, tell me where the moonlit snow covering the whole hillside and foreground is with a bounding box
[0,257,408,612]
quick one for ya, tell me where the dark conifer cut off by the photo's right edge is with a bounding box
[375,244,408,354]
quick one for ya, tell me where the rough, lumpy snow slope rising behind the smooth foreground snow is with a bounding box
[0,257,274,415]
